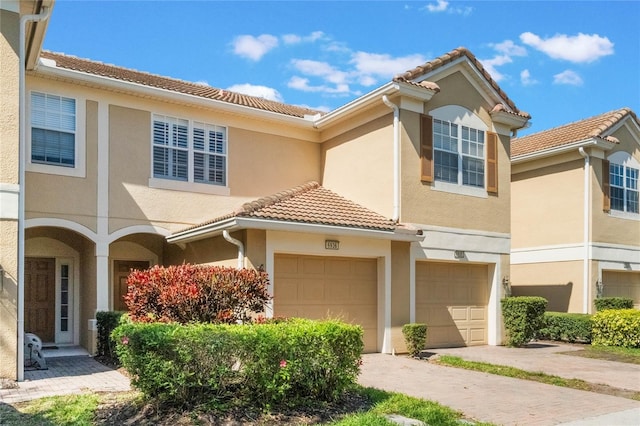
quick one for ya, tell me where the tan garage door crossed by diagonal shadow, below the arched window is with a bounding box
[416,262,489,348]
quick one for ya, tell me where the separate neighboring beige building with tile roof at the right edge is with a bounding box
[511,108,640,313]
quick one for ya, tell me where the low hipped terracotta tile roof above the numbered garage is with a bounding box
[180,182,399,232]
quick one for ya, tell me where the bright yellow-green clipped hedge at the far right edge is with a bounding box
[592,309,640,348]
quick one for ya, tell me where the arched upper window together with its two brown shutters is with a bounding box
[420,105,498,196]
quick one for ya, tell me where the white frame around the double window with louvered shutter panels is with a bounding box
[149,114,230,195]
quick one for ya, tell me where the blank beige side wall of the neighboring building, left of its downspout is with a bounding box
[511,158,584,249]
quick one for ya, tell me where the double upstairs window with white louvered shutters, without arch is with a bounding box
[152,115,227,186]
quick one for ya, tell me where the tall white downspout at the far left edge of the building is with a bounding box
[17,7,51,382]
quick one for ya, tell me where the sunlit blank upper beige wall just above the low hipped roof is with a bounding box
[321,110,393,217]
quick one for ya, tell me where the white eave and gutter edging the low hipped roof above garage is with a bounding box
[167,217,424,244]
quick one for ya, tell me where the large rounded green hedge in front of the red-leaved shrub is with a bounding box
[113,319,363,408]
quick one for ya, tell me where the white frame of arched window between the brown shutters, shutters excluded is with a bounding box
[429,105,490,198]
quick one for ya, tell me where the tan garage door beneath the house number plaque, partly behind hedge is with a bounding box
[273,254,378,352]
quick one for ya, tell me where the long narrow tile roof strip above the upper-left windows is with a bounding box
[40,50,323,118]
